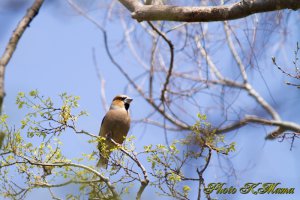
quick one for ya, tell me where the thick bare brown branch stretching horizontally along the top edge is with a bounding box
[119,0,300,22]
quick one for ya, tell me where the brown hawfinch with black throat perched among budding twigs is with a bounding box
[97,95,132,169]
